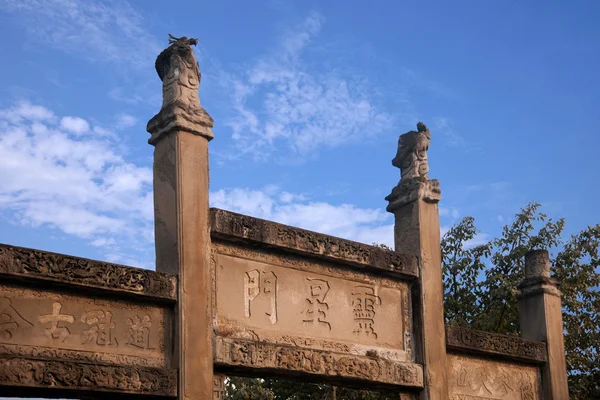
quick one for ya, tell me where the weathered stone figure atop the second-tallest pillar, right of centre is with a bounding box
[392,122,431,181]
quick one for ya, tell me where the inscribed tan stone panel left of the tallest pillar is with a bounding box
[0,285,171,367]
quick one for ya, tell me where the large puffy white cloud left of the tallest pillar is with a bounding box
[0,103,153,266]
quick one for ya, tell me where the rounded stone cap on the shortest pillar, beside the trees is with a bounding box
[519,250,561,297]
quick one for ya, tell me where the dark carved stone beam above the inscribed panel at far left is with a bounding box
[0,244,176,300]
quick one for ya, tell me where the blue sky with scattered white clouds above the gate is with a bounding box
[0,0,600,268]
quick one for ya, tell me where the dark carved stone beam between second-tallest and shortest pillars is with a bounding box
[446,325,547,363]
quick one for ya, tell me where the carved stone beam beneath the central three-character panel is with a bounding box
[215,337,423,387]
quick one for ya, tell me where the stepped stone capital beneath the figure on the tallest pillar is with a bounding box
[146,103,215,146]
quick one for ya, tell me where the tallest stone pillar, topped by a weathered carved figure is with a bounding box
[147,37,213,400]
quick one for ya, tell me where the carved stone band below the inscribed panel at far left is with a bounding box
[0,358,177,396]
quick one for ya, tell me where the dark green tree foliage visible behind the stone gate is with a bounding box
[227,203,600,400]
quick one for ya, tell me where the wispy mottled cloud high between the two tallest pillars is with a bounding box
[223,13,392,159]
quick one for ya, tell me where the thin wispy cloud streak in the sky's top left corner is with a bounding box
[0,0,161,68]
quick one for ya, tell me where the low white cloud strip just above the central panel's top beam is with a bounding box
[210,188,394,246]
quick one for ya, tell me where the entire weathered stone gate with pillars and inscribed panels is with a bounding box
[0,37,568,400]
